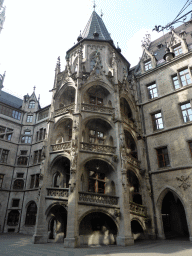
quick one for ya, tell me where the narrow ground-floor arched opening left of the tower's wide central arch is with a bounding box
[48,205,67,243]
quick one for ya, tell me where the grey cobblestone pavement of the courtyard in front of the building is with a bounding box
[0,234,192,256]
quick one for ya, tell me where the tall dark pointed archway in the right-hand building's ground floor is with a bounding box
[161,191,189,239]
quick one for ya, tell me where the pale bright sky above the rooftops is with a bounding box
[0,0,192,107]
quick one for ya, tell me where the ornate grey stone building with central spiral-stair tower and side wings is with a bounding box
[0,11,192,247]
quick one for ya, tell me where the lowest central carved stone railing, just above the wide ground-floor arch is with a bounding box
[79,192,118,206]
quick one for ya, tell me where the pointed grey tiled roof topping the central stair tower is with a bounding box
[82,11,112,41]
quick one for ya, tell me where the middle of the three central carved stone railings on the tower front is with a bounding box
[81,142,116,154]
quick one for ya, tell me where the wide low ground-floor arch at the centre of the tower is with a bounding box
[79,212,117,246]
